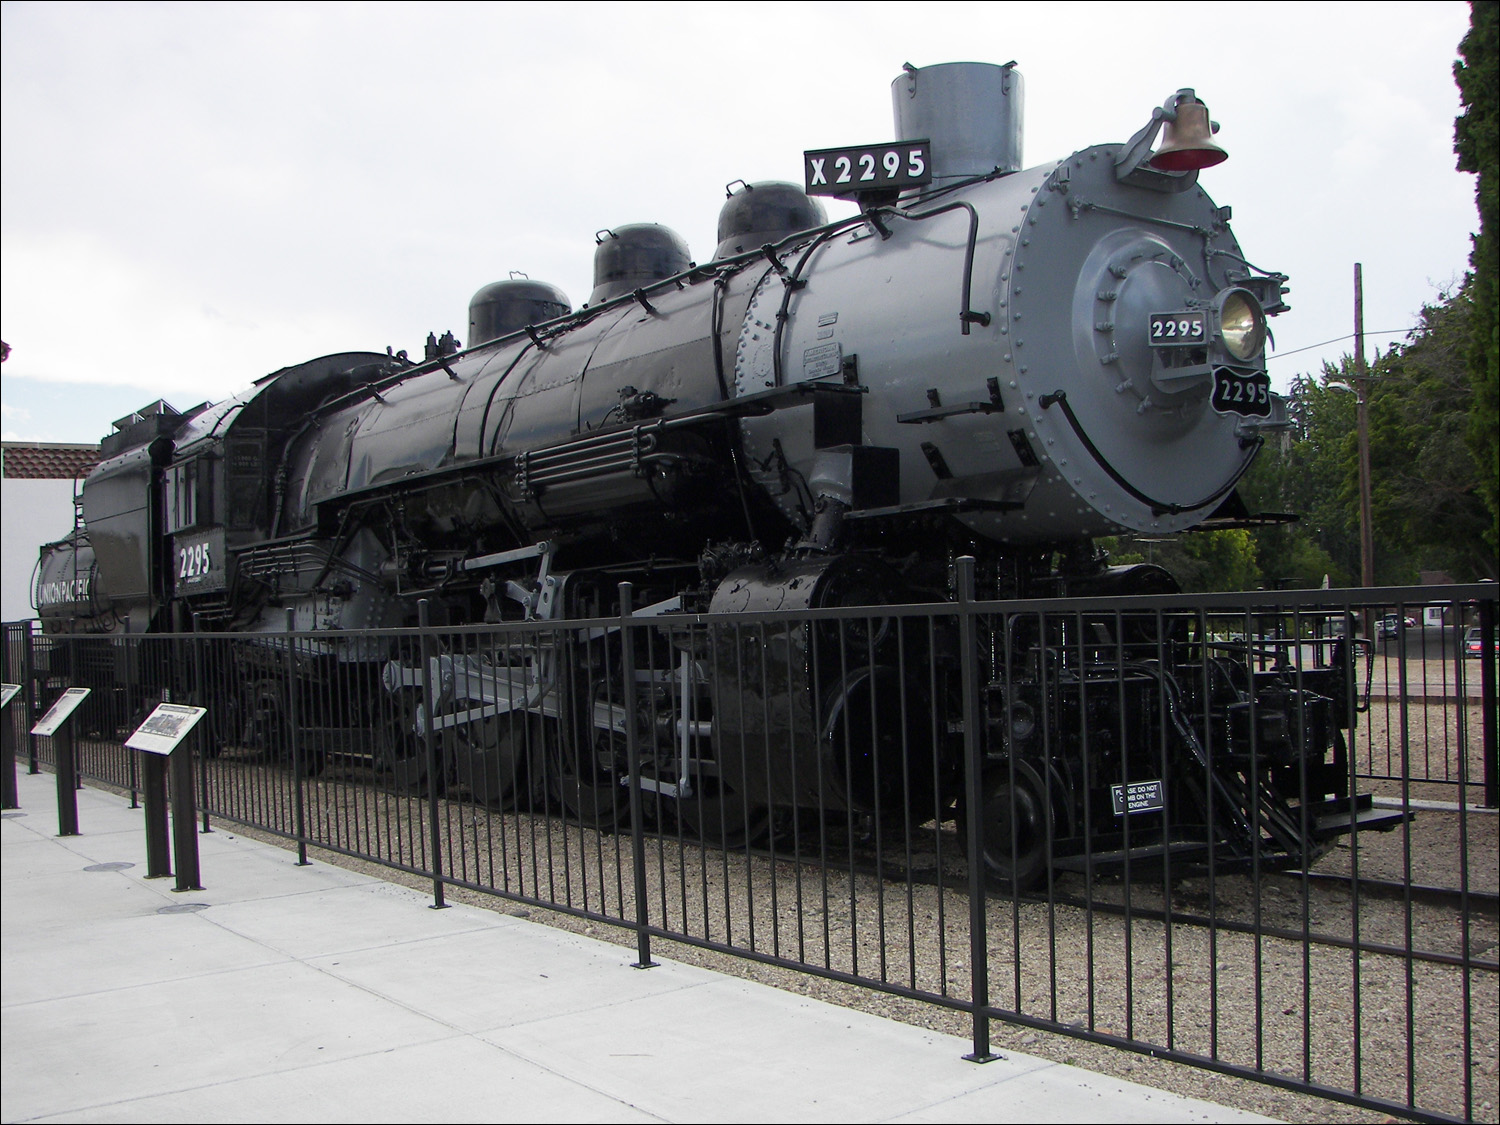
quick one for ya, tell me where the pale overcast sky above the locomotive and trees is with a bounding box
[0,3,1478,443]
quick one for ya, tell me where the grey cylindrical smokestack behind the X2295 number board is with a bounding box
[891,63,1026,186]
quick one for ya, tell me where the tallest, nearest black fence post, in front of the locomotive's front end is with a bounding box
[954,555,999,1062]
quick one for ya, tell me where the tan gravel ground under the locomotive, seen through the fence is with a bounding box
[178,759,1500,1121]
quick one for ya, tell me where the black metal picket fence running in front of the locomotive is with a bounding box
[5,585,1500,1119]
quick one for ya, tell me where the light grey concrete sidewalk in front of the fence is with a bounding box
[0,774,1266,1122]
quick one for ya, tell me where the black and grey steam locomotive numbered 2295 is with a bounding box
[38,63,1392,884]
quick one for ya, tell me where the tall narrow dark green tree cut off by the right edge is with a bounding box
[1454,0,1500,551]
